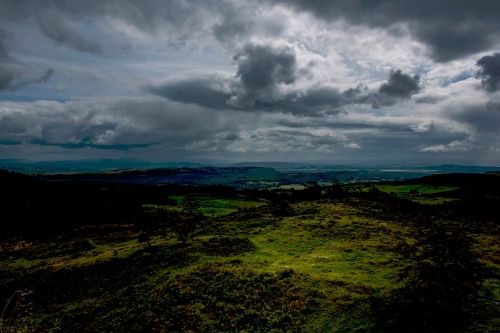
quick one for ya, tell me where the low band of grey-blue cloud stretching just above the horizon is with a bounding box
[0,97,492,163]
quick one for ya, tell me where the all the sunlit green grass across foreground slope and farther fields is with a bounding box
[0,189,499,332]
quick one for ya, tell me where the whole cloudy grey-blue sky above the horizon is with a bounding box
[0,0,500,165]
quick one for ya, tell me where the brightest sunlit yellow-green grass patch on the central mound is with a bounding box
[236,201,408,288]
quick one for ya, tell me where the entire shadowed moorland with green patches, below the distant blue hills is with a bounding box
[0,169,500,332]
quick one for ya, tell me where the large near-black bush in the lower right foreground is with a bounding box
[373,224,482,333]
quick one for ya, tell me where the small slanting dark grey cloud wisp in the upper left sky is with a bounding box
[39,15,103,54]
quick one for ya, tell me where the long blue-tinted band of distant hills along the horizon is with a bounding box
[0,159,500,188]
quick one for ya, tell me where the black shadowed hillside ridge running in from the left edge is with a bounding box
[0,170,235,238]
